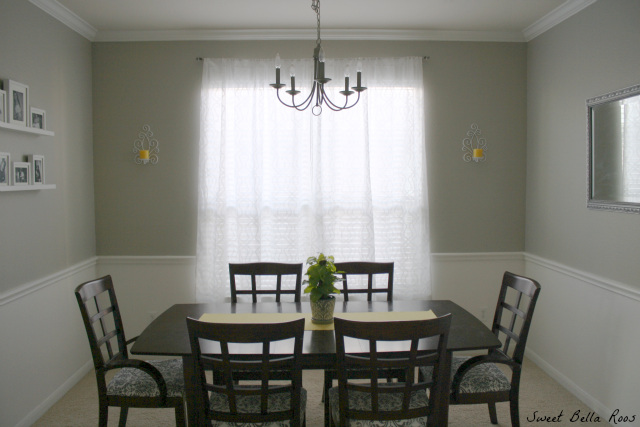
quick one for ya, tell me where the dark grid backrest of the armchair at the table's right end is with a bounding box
[491,271,540,364]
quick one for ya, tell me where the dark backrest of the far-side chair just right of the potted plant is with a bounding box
[335,261,393,301]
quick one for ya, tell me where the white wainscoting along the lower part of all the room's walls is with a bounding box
[0,252,640,427]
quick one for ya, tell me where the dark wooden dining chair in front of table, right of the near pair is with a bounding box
[329,314,451,427]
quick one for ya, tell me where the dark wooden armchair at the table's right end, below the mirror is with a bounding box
[420,271,540,427]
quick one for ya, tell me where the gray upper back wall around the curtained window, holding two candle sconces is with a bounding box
[92,41,526,255]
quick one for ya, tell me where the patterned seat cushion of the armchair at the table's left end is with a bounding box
[107,359,184,397]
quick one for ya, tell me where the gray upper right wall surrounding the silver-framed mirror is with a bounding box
[526,0,640,288]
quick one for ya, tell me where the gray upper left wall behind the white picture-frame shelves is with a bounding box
[0,0,95,294]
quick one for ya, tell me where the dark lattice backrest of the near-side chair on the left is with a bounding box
[187,318,304,427]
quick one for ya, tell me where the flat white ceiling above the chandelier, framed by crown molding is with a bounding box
[30,0,596,41]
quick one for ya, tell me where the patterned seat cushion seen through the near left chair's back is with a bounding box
[210,386,307,427]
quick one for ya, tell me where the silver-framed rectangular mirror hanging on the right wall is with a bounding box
[587,85,640,213]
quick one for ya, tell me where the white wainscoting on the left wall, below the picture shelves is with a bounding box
[0,258,97,427]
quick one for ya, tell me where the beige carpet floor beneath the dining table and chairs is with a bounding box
[34,359,610,427]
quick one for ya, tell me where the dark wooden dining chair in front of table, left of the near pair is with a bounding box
[187,318,307,427]
